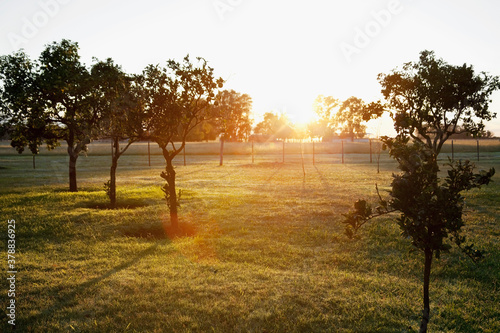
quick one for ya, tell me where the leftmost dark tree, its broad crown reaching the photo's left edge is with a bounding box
[2,39,99,188]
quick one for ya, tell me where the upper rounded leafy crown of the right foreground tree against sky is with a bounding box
[378,51,500,154]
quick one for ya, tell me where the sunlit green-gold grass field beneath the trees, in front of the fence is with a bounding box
[0,144,500,333]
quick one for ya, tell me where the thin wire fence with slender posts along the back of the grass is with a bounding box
[0,139,500,166]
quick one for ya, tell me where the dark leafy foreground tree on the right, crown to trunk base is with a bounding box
[344,51,500,332]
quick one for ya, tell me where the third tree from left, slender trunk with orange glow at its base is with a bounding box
[138,56,223,230]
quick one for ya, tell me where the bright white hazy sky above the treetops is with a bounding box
[0,0,500,136]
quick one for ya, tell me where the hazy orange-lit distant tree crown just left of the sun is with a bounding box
[215,90,252,142]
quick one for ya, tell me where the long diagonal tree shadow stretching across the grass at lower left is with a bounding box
[24,239,168,325]
